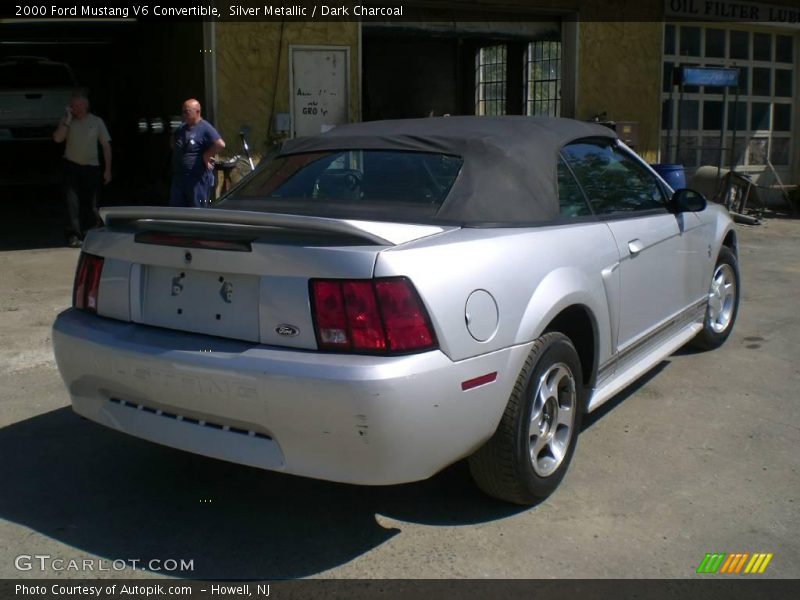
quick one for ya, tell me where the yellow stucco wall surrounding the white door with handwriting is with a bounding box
[214,21,360,162]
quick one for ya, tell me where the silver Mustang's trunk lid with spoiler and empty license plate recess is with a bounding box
[91,207,454,349]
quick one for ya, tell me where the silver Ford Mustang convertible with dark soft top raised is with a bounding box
[53,117,740,504]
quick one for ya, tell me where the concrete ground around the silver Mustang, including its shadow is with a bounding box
[0,200,800,579]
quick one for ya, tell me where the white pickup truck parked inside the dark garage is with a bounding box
[0,56,78,144]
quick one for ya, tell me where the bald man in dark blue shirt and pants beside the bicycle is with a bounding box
[169,98,225,207]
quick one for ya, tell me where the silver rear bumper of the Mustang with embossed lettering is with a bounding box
[53,309,530,485]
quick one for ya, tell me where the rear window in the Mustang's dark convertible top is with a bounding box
[222,149,463,221]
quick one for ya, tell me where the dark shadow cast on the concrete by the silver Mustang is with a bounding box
[0,408,525,579]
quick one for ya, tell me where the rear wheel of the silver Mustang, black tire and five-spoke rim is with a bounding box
[469,332,585,506]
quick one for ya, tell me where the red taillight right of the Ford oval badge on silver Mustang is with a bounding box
[311,277,436,354]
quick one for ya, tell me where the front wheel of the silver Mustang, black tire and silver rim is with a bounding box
[692,246,740,350]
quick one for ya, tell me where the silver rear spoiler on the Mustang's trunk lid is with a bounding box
[100,206,456,246]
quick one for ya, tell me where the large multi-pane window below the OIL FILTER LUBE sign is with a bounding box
[661,24,797,171]
